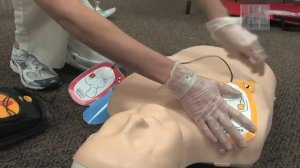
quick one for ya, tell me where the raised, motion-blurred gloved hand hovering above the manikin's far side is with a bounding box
[206,17,267,64]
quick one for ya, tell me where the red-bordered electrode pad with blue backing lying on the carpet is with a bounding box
[69,62,125,125]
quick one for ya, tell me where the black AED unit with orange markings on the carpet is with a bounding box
[0,87,51,148]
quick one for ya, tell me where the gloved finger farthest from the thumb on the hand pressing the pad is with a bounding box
[206,118,232,150]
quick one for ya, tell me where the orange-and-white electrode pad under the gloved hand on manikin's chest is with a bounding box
[225,81,258,141]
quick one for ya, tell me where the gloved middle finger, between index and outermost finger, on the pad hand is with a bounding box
[218,113,247,147]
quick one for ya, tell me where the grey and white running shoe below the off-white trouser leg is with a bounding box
[10,47,61,90]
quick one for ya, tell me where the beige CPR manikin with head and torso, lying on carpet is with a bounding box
[72,46,276,168]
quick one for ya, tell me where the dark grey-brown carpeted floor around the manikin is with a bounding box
[0,0,300,168]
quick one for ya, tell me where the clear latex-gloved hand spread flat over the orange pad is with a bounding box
[166,63,256,150]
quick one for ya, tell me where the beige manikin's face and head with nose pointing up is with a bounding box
[74,104,183,168]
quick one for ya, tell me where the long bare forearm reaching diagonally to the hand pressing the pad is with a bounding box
[36,0,174,83]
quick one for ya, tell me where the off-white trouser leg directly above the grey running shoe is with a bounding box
[12,0,69,68]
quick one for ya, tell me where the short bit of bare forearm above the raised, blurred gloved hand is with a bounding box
[197,0,228,20]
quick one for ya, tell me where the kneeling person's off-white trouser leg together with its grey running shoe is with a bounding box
[11,0,69,89]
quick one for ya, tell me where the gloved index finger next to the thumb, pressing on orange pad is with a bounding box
[226,105,256,132]
